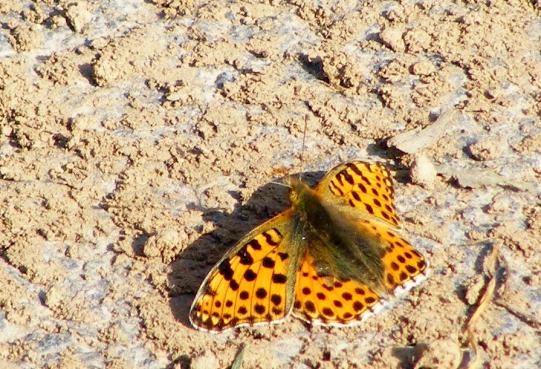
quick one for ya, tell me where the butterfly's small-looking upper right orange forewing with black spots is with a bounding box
[314,161,399,227]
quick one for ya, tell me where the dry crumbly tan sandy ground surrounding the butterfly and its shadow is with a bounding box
[0,0,541,369]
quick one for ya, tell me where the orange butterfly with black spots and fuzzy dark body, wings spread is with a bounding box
[189,161,428,332]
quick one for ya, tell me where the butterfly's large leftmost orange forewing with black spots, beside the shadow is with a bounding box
[190,209,299,331]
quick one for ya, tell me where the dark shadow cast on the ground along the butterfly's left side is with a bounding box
[167,172,325,327]
